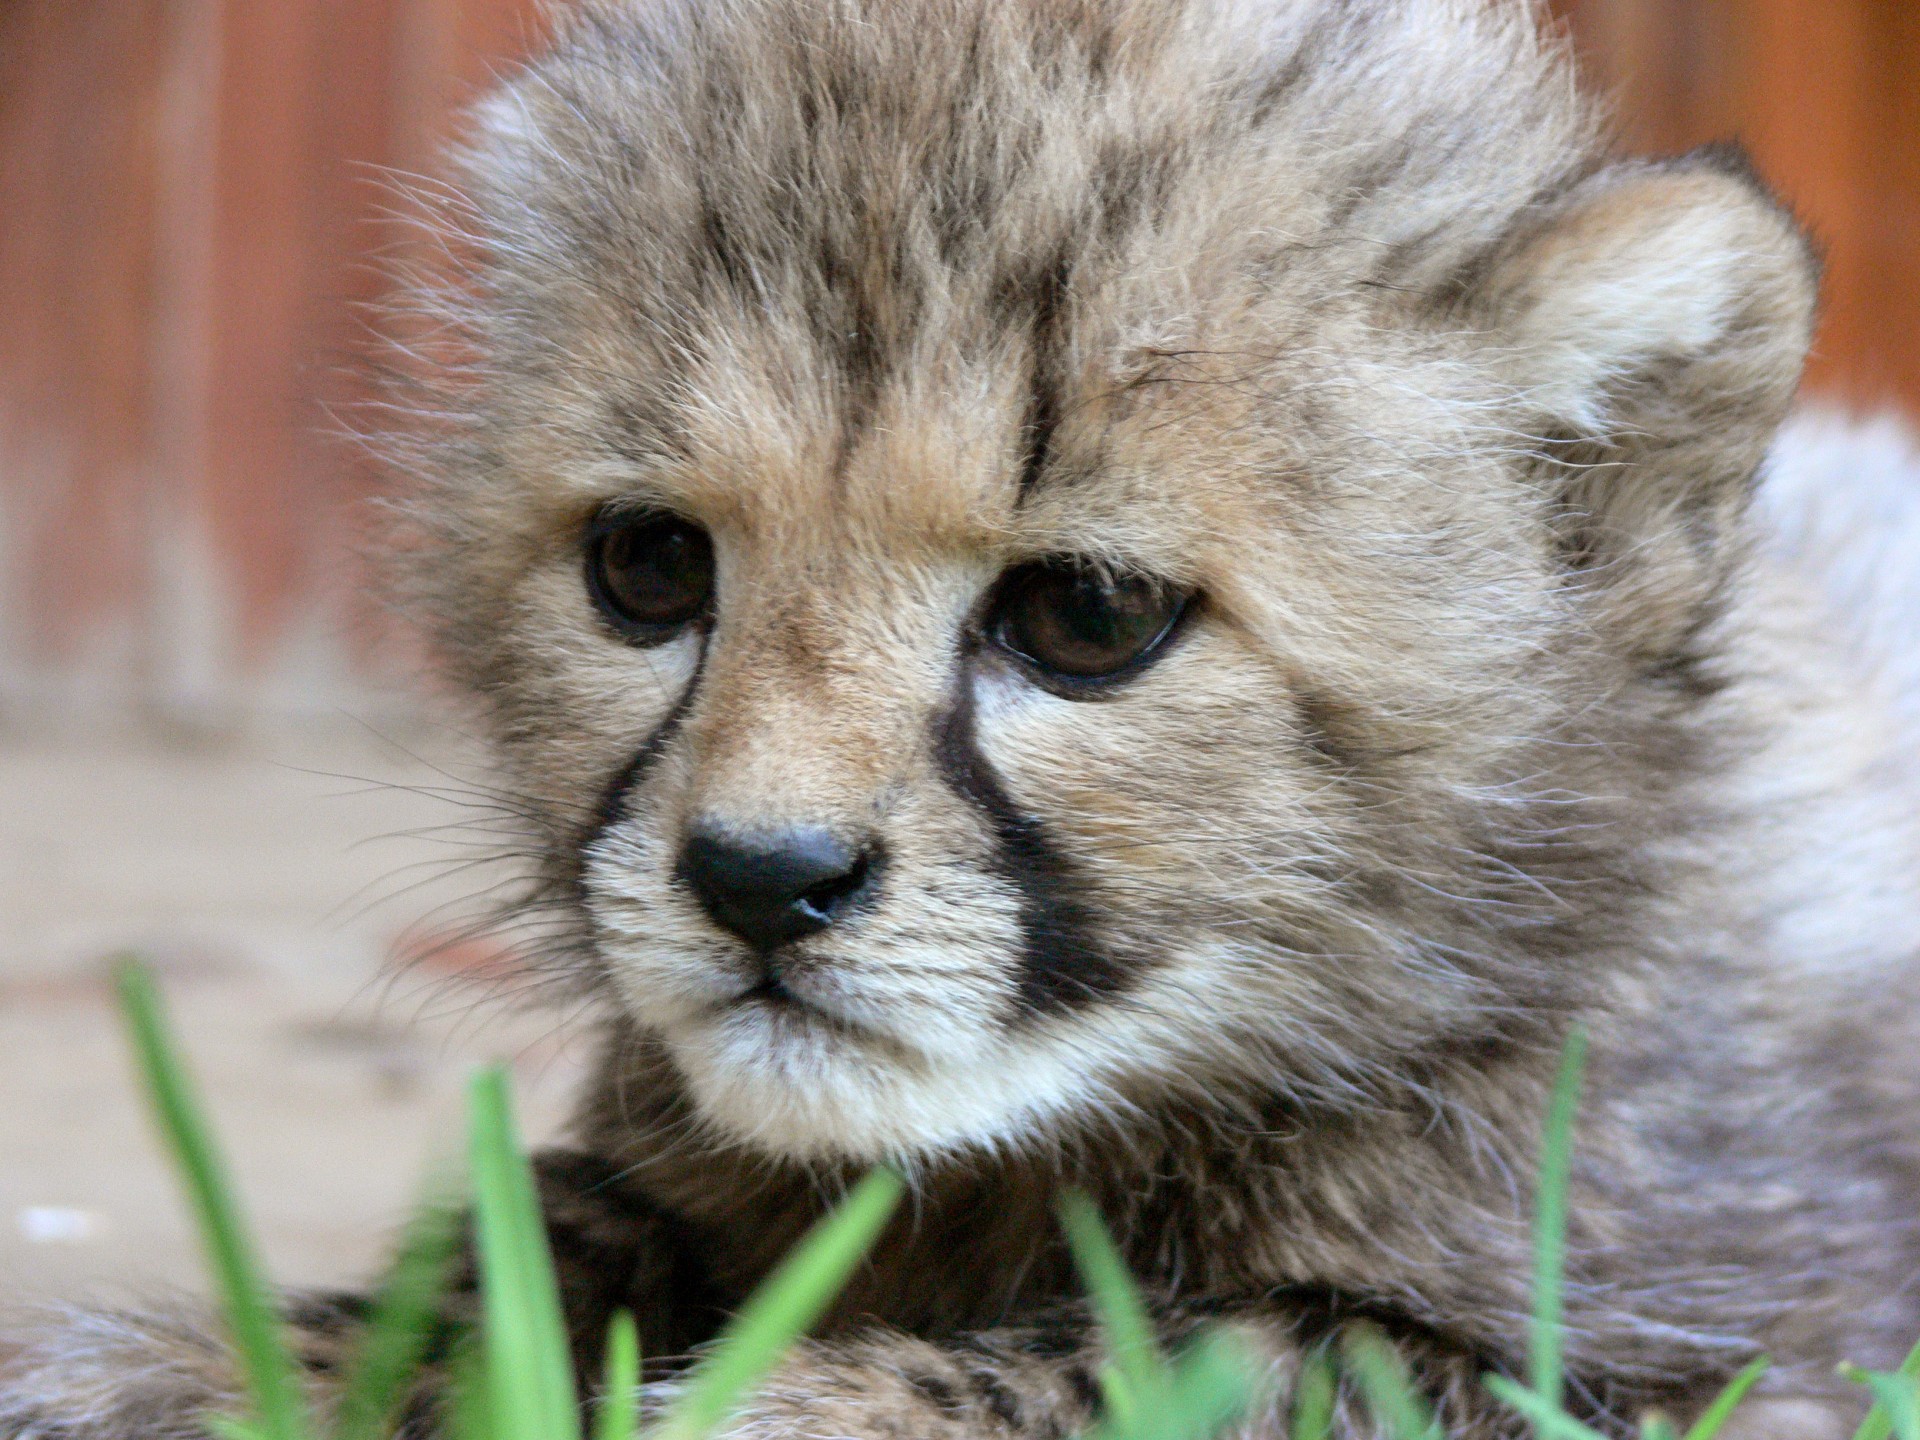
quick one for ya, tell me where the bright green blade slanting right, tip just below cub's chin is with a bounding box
[655,1169,904,1440]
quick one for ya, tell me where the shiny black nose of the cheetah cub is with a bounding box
[680,826,876,950]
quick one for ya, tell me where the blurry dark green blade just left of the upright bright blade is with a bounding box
[332,1202,463,1440]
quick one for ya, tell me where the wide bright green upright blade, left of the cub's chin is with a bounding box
[470,1068,580,1440]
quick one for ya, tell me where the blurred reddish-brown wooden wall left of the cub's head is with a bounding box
[0,0,549,718]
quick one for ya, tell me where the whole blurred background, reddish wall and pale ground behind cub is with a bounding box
[0,0,1920,1304]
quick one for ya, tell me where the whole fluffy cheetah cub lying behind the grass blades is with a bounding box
[11,0,1920,1440]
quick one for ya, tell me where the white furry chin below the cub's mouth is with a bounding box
[660,998,1092,1169]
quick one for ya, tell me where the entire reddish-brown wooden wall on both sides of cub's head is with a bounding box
[0,0,1920,712]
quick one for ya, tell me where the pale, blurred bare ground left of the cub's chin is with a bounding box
[0,732,582,1306]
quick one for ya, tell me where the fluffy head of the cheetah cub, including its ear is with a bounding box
[405,0,1811,1160]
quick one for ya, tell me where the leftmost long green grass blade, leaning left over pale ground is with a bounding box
[115,960,309,1440]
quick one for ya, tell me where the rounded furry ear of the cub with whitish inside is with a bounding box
[1480,150,1818,662]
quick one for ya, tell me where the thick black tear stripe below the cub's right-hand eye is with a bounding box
[933,687,1133,1014]
